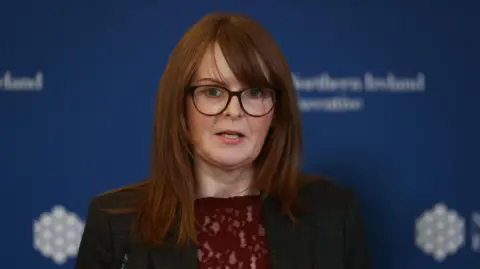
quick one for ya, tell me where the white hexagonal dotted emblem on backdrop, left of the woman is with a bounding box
[33,205,84,265]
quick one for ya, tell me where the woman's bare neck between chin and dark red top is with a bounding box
[195,157,254,198]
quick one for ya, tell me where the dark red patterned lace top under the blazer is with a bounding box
[195,196,270,269]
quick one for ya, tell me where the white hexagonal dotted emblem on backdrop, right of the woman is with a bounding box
[415,204,465,262]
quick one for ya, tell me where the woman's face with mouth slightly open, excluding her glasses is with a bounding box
[187,45,274,169]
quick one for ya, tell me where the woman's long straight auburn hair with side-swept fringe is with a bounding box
[109,13,302,245]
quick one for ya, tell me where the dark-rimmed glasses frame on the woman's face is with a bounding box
[186,84,278,118]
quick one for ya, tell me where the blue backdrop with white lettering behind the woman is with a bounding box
[0,0,480,269]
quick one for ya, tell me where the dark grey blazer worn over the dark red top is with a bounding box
[75,175,372,269]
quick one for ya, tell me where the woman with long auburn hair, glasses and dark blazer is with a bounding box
[75,13,371,269]
